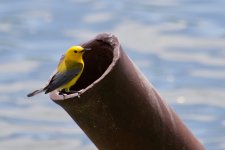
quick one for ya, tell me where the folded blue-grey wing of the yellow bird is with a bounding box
[45,64,82,94]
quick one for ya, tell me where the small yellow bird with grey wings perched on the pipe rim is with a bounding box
[27,45,91,97]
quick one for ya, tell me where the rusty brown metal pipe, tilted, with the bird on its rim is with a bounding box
[50,34,204,150]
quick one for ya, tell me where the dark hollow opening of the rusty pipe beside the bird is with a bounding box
[68,39,113,91]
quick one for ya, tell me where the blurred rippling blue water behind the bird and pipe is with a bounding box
[0,0,225,150]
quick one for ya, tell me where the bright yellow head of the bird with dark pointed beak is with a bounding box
[66,46,90,61]
